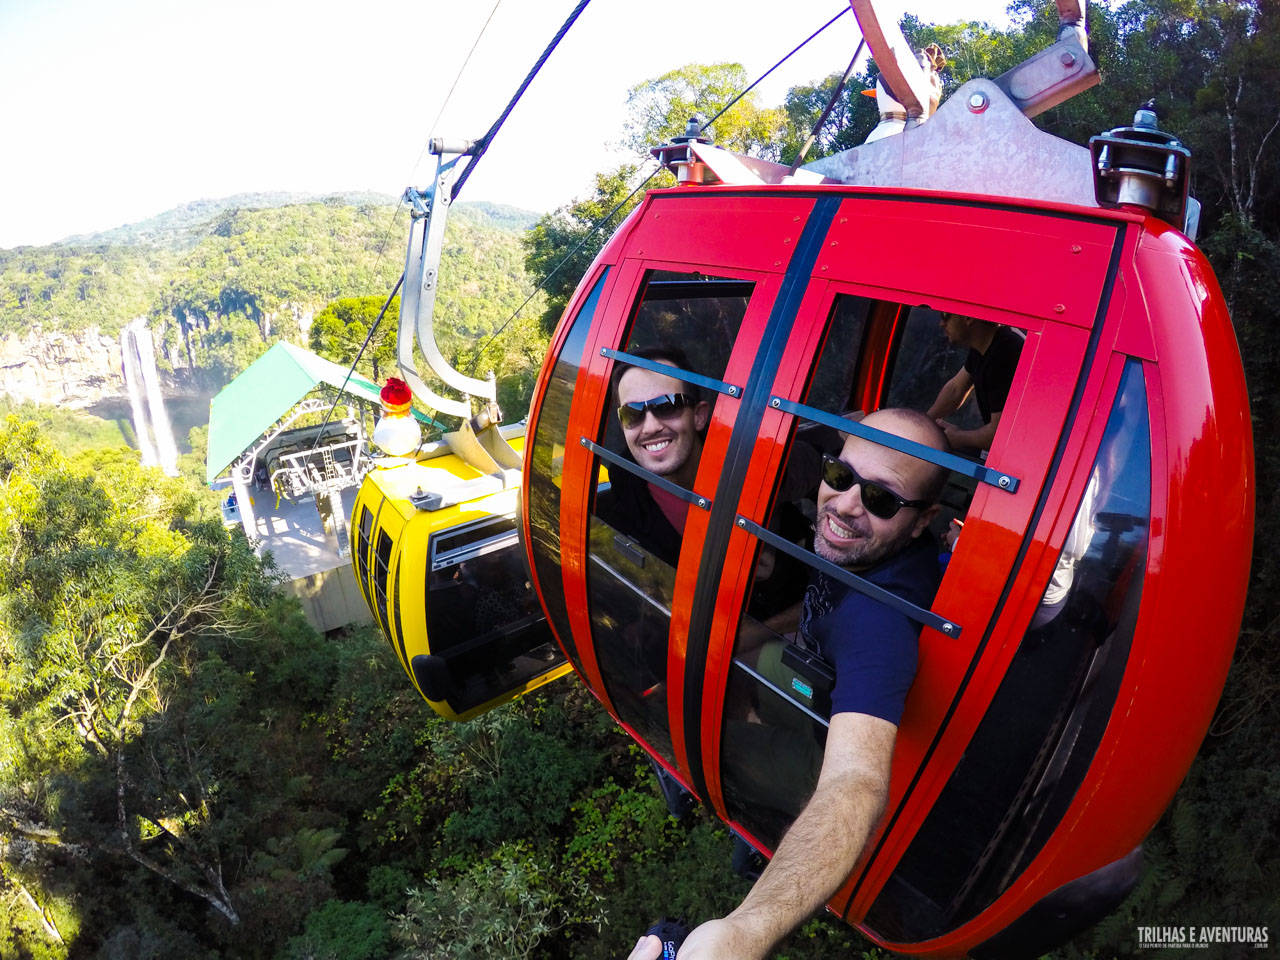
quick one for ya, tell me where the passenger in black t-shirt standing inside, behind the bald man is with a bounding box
[928,314,1023,453]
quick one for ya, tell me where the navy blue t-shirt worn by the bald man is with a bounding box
[800,531,941,724]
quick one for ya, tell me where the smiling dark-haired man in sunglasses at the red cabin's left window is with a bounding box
[596,347,710,567]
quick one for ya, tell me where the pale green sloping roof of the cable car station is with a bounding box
[205,340,439,483]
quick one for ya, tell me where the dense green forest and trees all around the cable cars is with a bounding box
[0,0,1280,960]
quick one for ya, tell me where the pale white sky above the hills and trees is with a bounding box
[0,0,1007,248]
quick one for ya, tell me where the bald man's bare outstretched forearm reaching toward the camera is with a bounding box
[680,713,897,960]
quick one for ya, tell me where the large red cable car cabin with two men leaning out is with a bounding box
[521,4,1253,957]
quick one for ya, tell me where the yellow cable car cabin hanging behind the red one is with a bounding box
[352,424,570,721]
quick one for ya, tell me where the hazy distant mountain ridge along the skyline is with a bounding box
[57,191,540,250]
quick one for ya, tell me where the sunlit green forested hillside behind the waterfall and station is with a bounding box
[0,195,543,417]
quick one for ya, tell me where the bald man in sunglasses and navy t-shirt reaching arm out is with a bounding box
[628,410,948,960]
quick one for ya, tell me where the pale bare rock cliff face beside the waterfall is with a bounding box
[0,326,189,407]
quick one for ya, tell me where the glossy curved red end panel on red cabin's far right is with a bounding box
[972,221,1253,911]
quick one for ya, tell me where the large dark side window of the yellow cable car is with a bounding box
[415,529,558,713]
